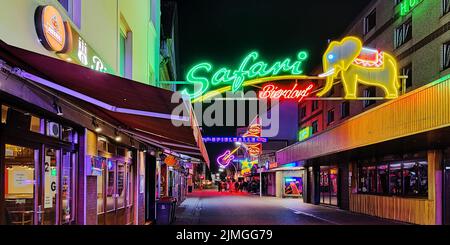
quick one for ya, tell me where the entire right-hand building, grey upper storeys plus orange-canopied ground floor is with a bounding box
[277,0,450,224]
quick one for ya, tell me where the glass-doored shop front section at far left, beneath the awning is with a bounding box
[0,101,82,225]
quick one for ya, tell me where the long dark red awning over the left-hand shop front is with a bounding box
[0,41,209,165]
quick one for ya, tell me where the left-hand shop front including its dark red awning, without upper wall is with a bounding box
[0,41,209,225]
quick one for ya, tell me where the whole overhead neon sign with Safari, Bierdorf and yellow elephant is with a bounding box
[182,36,400,103]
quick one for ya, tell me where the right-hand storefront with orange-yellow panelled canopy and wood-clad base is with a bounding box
[277,74,450,224]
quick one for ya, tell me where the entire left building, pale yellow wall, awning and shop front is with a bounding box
[0,0,209,225]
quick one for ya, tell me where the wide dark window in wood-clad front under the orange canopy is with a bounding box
[358,161,428,196]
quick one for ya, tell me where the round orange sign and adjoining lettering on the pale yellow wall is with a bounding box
[35,5,113,73]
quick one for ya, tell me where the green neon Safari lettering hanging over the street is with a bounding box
[182,51,308,99]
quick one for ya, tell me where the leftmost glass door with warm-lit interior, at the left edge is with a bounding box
[4,144,39,225]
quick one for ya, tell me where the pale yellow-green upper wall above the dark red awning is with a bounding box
[0,0,159,85]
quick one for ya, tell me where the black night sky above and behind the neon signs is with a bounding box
[177,0,370,172]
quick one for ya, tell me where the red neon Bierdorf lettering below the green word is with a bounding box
[259,83,314,102]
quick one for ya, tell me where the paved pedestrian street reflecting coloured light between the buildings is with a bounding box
[175,190,406,225]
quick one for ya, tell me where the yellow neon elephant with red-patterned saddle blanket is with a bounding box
[317,37,400,100]
